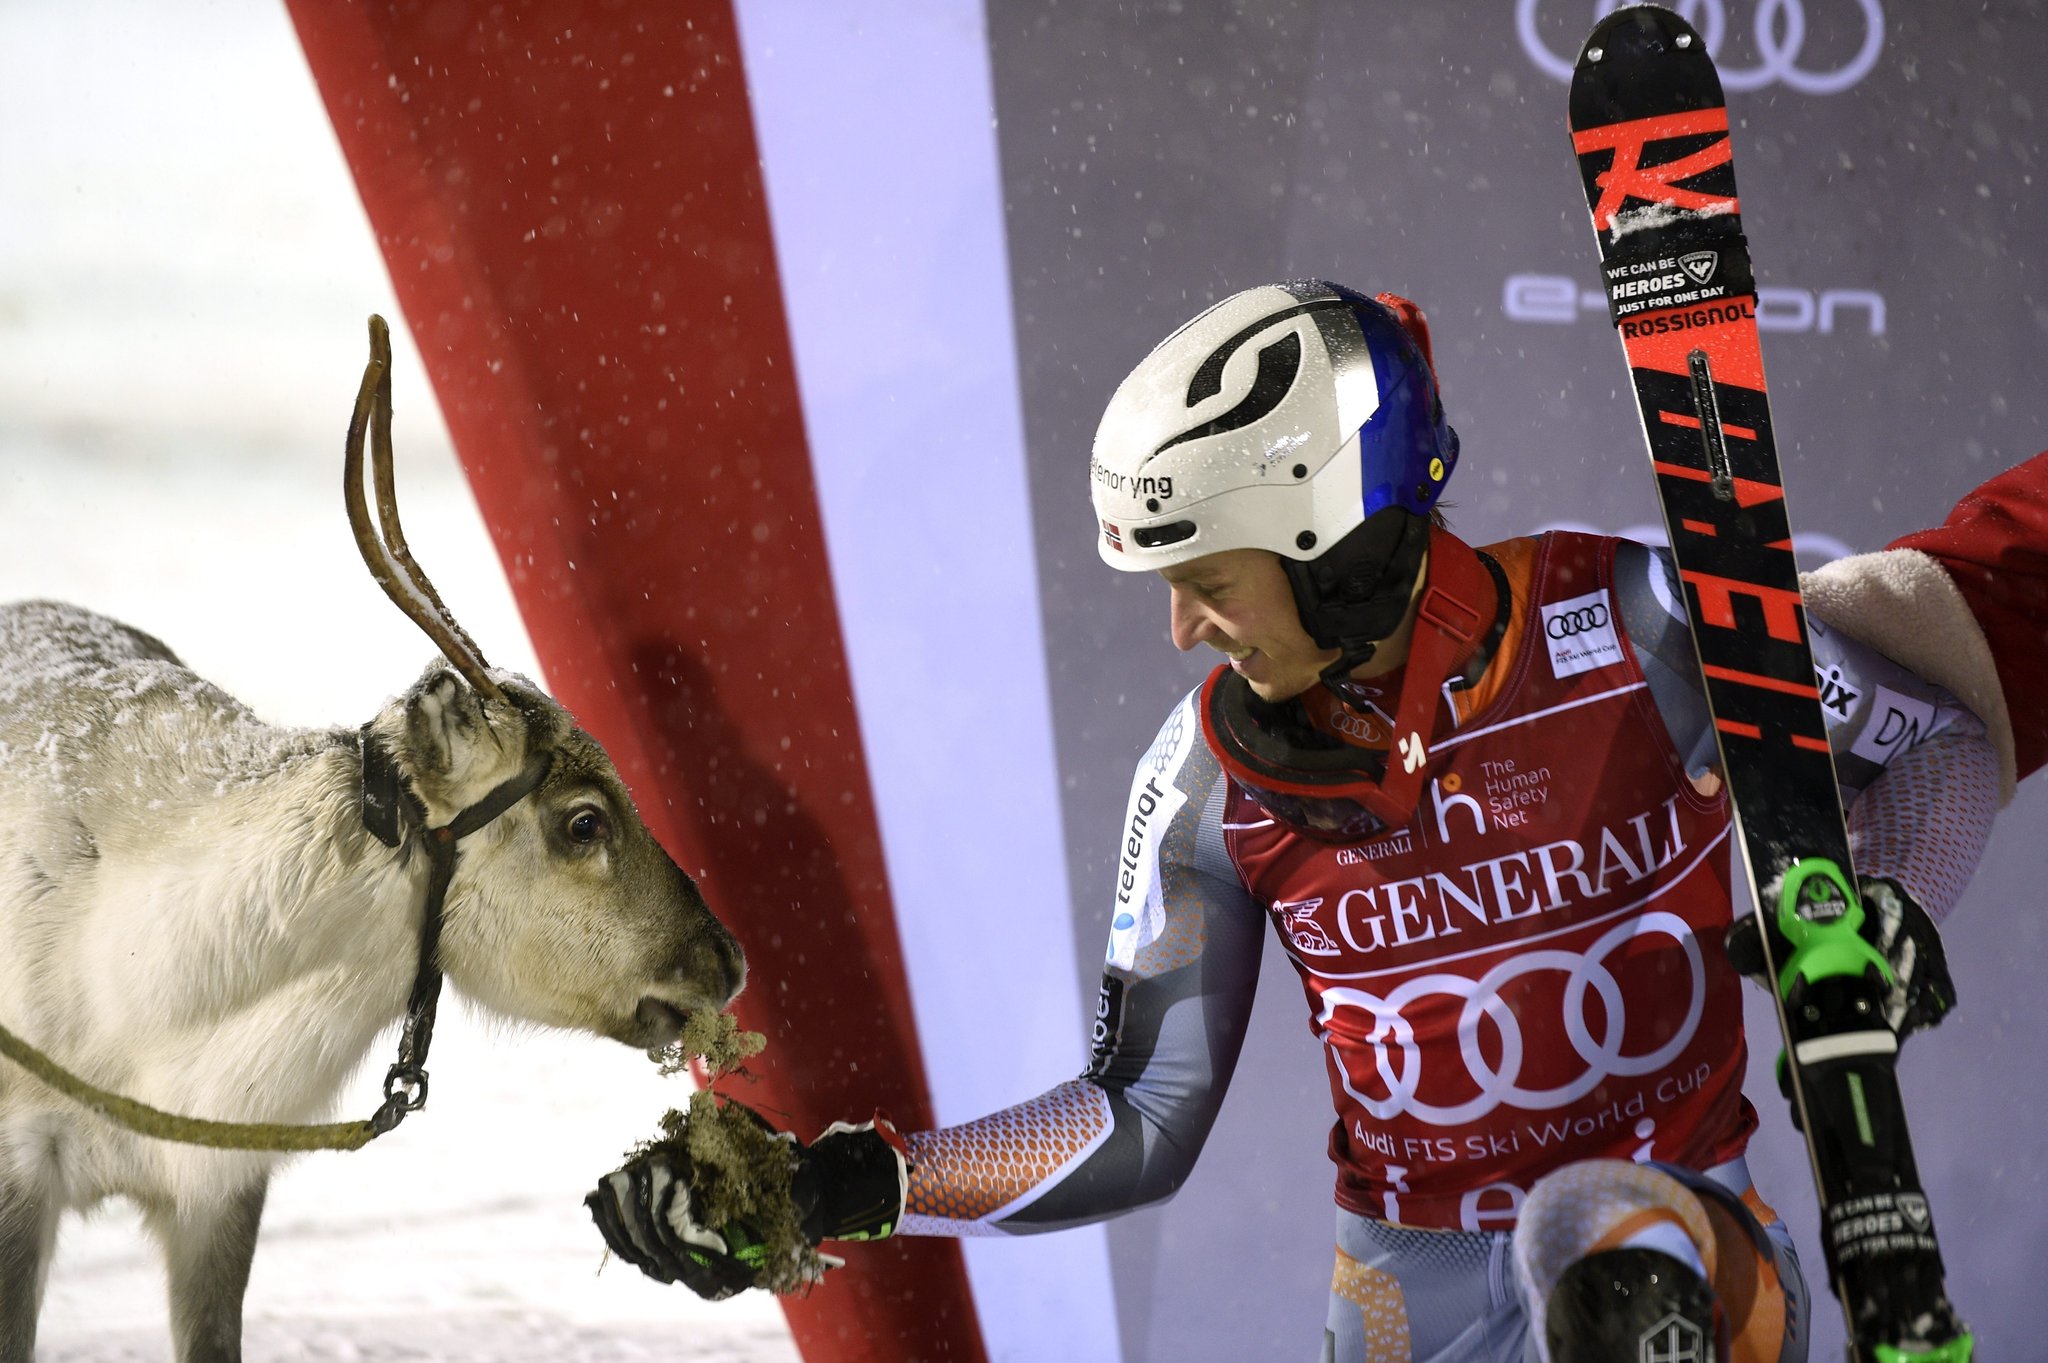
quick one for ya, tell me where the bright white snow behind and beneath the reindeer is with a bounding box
[0,0,797,1363]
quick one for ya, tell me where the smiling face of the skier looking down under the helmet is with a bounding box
[1159,548,1337,700]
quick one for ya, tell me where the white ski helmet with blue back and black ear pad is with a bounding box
[1090,280,1458,665]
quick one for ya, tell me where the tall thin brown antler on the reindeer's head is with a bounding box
[342,313,504,700]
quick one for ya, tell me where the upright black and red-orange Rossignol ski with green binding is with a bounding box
[1571,4,1972,1363]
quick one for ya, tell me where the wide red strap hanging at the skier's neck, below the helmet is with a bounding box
[1323,517,1499,829]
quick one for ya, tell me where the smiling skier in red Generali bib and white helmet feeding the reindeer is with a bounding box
[588,280,1999,1363]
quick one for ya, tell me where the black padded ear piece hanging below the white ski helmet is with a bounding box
[1280,505,1430,669]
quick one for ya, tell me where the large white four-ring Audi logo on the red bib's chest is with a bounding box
[1317,911,1706,1126]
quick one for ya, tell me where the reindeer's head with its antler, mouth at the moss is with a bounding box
[344,317,745,1048]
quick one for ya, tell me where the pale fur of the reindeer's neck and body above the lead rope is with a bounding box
[0,605,426,1122]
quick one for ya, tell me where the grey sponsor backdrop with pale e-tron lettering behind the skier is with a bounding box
[989,0,2048,1361]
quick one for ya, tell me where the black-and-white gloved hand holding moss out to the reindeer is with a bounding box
[584,1111,909,1302]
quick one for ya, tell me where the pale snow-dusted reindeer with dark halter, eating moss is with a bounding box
[0,317,745,1363]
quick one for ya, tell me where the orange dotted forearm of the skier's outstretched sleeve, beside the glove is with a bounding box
[901,1079,1114,1236]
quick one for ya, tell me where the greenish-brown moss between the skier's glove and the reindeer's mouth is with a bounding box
[627,1011,831,1293]
